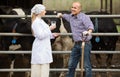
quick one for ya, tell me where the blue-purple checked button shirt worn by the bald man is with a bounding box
[63,13,94,42]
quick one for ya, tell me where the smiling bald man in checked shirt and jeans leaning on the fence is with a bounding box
[58,2,94,77]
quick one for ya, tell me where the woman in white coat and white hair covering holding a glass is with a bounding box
[31,4,58,77]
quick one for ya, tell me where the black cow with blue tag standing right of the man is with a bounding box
[86,11,118,77]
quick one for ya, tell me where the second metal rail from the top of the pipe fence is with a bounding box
[0,33,120,36]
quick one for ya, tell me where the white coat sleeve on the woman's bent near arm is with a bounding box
[32,22,52,39]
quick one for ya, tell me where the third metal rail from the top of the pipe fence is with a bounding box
[0,51,120,54]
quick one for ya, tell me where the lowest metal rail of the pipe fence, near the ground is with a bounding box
[0,68,120,72]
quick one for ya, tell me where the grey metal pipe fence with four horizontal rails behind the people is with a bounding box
[0,15,120,72]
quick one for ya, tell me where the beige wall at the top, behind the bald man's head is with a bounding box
[43,0,120,14]
